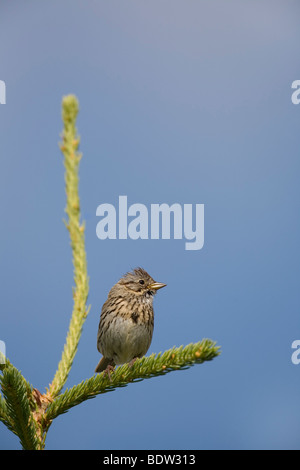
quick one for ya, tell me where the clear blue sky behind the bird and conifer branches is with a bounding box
[0,0,300,449]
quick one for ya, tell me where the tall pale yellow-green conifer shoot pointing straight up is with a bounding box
[49,95,89,397]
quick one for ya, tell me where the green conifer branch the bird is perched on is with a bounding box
[45,339,220,422]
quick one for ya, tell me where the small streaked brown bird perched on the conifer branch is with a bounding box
[95,268,166,373]
